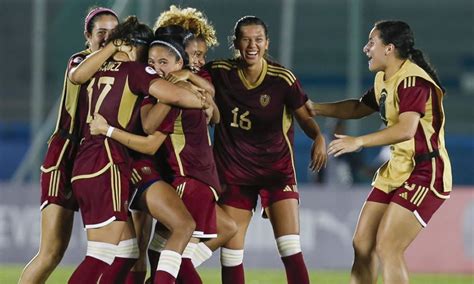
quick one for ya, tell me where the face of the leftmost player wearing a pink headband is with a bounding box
[84,14,118,51]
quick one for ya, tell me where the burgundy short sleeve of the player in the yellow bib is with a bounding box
[398,77,433,117]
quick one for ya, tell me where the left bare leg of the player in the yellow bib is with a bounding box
[349,201,388,284]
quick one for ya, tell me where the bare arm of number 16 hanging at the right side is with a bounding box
[294,105,327,171]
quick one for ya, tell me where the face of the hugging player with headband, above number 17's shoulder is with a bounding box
[148,45,183,77]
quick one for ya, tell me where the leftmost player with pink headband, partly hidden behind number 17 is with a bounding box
[19,7,118,283]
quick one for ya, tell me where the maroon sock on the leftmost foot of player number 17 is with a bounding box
[68,256,109,284]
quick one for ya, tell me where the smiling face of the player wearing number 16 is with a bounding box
[234,25,270,66]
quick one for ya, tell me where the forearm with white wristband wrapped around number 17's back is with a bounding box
[90,113,167,155]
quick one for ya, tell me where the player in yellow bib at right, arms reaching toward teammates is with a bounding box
[313,21,452,284]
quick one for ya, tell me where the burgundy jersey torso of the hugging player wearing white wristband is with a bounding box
[157,107,220,192]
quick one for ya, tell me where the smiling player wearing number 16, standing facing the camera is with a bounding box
[199,16,327,283]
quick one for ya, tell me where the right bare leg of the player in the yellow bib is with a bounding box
[376,203,423,284]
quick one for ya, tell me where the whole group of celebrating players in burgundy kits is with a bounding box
[20,2,451,284]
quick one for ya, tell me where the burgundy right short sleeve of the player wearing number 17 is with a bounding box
[128,62,160,96]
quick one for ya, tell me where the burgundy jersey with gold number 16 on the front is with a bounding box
[201,60,308,185]
